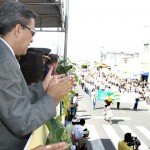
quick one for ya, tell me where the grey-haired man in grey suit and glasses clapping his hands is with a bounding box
[0,2,73,150]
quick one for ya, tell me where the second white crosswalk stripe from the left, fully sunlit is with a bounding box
[103,125,121,149]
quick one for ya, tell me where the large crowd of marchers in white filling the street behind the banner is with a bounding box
[78,69,150,110]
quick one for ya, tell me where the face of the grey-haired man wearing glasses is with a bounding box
[17,19,35,55]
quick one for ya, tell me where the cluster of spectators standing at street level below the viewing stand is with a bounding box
[65,93,89,150]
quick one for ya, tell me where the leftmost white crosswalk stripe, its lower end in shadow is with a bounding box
[86,124,105,150]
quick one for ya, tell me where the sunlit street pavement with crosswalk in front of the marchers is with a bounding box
[75,86,150,150]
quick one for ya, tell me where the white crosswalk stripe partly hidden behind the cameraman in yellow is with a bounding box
[119,125,148,150]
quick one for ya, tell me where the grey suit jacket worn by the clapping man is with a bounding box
[0,39,56,150]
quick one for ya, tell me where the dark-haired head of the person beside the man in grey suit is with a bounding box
[19,48,44,85]
